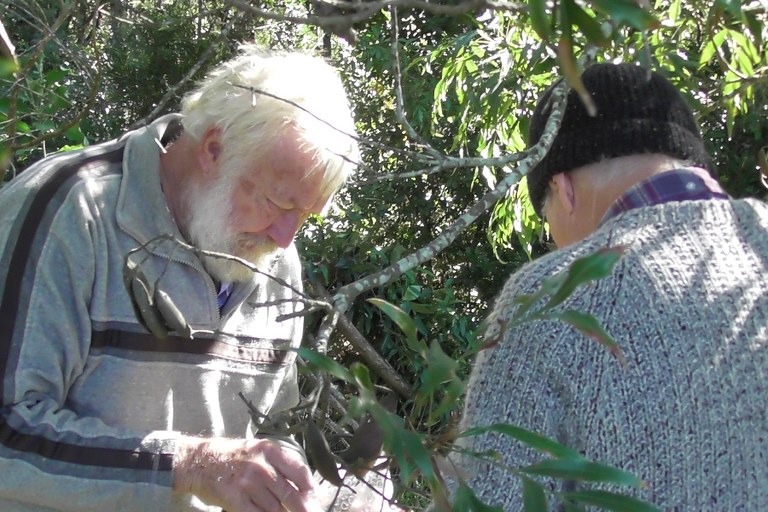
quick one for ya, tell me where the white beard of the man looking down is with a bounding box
[184,173,283,282]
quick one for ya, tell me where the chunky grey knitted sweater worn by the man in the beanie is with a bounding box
[462,200,768,511]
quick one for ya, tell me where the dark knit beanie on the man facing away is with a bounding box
[528,64,714,216]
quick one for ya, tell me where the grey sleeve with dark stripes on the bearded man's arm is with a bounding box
[0,177,177,512]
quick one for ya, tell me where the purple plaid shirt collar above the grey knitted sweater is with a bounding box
[600,167,729,225]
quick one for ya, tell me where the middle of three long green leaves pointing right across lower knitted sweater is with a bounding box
[520,458,647,488]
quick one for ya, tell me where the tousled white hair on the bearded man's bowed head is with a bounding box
[181,45,359,201]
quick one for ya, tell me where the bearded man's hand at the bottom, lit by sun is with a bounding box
[173,438,322,512]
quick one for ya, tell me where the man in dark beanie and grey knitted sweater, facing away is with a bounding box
[450,64,768,511]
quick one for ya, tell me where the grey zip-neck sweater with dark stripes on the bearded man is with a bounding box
[0,116,302,512]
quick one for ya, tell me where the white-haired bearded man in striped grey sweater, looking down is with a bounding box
[0,47,358,512]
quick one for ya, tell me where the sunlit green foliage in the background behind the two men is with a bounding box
[0,0,768,505]
